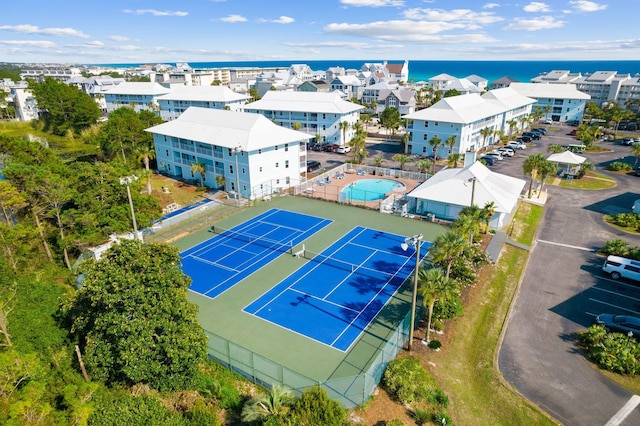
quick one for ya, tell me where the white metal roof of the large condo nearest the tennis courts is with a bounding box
[146,107,314,151]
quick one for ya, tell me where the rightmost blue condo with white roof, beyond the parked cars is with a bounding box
[509,83,590,122]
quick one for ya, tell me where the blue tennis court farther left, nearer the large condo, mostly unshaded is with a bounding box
[181,209,331,298]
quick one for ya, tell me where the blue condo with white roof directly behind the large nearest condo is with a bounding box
[157,86,250,121]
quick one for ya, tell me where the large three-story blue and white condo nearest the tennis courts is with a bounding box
[147,107,312,199]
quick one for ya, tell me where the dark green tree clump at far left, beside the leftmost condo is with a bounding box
[31,78,101,136]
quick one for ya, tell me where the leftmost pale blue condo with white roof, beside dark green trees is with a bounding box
[104,82,171,113]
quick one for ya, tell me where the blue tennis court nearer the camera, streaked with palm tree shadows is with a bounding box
[244,227,432,351]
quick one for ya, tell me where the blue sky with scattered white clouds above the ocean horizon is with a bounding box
[0,0,640,63]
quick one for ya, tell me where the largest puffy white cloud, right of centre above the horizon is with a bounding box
[324,20,496,43]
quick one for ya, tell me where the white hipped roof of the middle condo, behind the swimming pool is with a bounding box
[245,90,364,114]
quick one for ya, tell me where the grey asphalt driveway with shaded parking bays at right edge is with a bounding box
[493,126,640,425]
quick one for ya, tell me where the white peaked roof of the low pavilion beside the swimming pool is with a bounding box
[408,161,526,213]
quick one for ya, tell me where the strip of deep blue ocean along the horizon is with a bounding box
[87,59,640,83]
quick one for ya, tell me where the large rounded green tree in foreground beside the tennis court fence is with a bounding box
[66,240,207,390]
